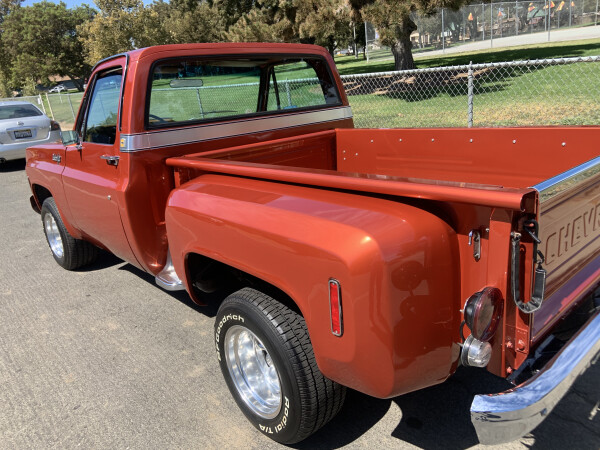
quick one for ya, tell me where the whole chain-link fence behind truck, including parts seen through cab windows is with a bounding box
[6,56,600,130]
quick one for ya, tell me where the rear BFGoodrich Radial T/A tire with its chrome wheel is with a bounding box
[215,288,346,444]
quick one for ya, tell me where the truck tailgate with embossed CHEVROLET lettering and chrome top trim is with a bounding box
[532,157,600,340]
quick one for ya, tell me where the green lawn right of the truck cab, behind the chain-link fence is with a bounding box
[336,39,600,128]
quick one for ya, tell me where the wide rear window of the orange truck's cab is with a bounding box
[146,55,341,128]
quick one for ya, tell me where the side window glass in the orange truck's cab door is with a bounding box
[83,69,122,145]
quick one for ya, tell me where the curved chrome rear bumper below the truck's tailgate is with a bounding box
[471,312,600,445]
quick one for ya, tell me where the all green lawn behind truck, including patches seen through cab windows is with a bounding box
[42,39,600,129]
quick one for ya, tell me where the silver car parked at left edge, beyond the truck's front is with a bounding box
[0,101,60,163]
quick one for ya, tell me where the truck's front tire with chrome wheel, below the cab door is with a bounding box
[41,197,98,270]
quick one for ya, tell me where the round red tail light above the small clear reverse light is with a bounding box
[464,287,504,341]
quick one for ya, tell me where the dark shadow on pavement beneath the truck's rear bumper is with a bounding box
[294,364,600,450]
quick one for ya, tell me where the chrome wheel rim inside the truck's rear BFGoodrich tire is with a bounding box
[224,325,281,419]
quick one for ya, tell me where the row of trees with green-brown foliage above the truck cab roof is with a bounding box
[0,0,478,95]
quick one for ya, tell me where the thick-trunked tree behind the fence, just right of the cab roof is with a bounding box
[350,0,468,70]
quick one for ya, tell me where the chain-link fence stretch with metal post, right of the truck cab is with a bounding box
[342,56,600,128]
